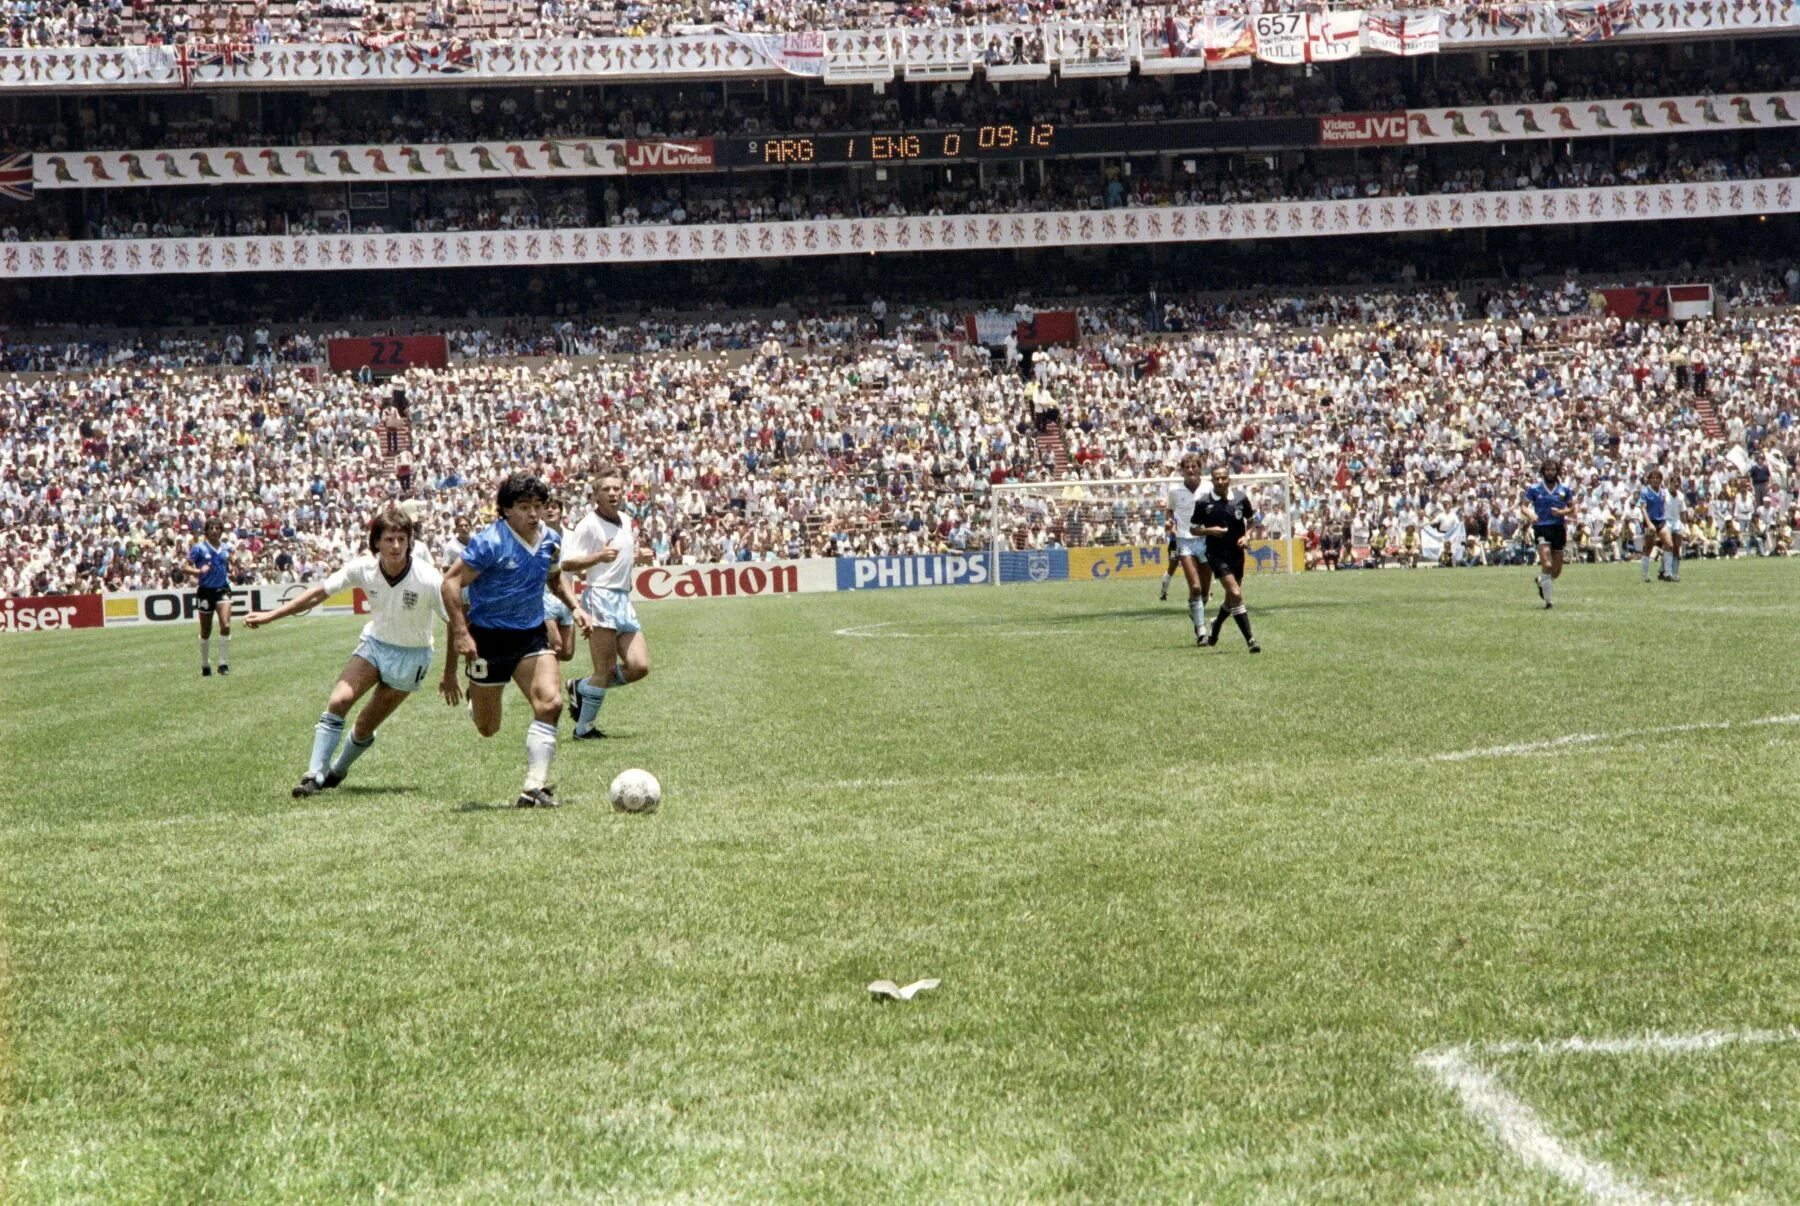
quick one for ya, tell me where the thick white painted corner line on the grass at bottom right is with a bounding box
[1417,1030,1800,1206]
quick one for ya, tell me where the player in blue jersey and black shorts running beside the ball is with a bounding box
[443,473,590,808]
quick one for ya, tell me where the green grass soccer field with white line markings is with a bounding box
[0,562,1800,1202]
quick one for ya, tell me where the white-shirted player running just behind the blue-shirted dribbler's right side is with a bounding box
[562,468,650,742]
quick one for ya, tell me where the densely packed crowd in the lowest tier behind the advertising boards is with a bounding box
[0,286,1800,594]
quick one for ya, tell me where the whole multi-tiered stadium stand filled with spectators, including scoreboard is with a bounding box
[0,0,1800,594]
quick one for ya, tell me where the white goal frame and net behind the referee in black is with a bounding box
[988,473,1305,583]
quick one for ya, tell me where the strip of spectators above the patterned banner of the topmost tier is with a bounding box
[0,0,1756,47]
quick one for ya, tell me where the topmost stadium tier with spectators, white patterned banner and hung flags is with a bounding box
[0,0,1800,88]
